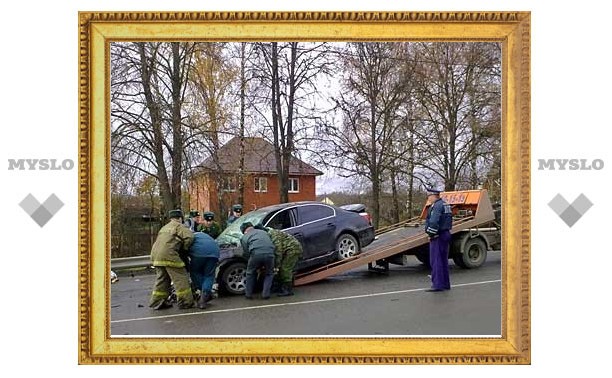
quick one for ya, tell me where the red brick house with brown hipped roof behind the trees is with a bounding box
[189,137,323,220]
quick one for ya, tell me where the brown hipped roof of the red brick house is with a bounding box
[199,137,323,176]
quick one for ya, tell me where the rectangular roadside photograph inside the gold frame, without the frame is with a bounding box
[109,41,503,338]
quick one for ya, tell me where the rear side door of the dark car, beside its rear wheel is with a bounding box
[297,204,336,259]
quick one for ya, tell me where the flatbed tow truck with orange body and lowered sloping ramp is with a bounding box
[295,189,501,286]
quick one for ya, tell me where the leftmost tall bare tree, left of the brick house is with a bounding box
[111,42,193,213]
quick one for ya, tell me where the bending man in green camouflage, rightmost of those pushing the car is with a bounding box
[255,225,302,297]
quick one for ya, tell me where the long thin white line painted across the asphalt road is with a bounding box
[111,280,501,324]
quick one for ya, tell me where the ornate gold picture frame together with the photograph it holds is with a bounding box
[79,12,530,364]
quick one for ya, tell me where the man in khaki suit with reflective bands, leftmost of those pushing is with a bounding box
[149,210,195,310]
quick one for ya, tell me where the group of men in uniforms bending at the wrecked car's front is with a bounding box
[149,205,302,310]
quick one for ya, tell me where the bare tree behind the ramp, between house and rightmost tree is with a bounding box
[324,42,409,227]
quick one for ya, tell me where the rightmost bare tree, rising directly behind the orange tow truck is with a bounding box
[408,42,501,190]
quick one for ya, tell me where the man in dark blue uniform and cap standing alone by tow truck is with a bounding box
[425,187,453,292]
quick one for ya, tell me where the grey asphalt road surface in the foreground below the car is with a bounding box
[110,251,502,337]
